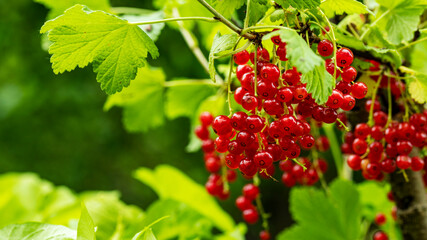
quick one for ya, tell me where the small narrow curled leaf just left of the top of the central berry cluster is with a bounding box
[209,32,239,82]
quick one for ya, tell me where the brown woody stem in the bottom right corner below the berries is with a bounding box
[390,170,427,240]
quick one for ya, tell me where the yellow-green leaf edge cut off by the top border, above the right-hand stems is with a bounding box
[320,0,371,17]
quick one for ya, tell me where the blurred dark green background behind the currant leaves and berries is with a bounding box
[0,0,342,236]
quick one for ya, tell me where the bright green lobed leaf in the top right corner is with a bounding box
[377,0,427,45]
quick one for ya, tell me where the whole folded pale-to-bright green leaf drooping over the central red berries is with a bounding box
[263,29,334,104]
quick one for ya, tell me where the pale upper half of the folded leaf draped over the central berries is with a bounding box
[263,29,325,74]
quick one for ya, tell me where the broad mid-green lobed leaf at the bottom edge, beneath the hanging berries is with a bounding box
[278,180,361,240]
